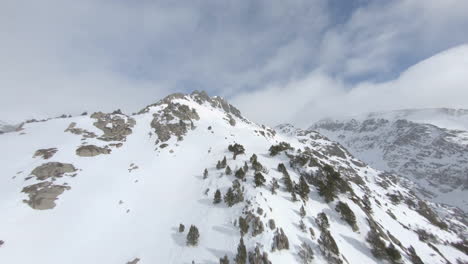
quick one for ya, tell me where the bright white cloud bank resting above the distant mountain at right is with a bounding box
[232,45,468,126]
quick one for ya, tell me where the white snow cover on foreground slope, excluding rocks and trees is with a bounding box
[0,93,468,264]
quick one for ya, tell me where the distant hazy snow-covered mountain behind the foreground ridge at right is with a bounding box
[310,109,468,211]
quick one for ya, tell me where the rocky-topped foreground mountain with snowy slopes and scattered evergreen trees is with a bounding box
[0,92,468,264]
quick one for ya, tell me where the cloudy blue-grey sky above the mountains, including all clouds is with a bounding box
[0,0,468,126]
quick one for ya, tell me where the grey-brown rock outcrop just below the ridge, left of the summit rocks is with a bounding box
[91,112,136,141]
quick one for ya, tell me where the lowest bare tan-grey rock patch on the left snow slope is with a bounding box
[21,182,70,210]
